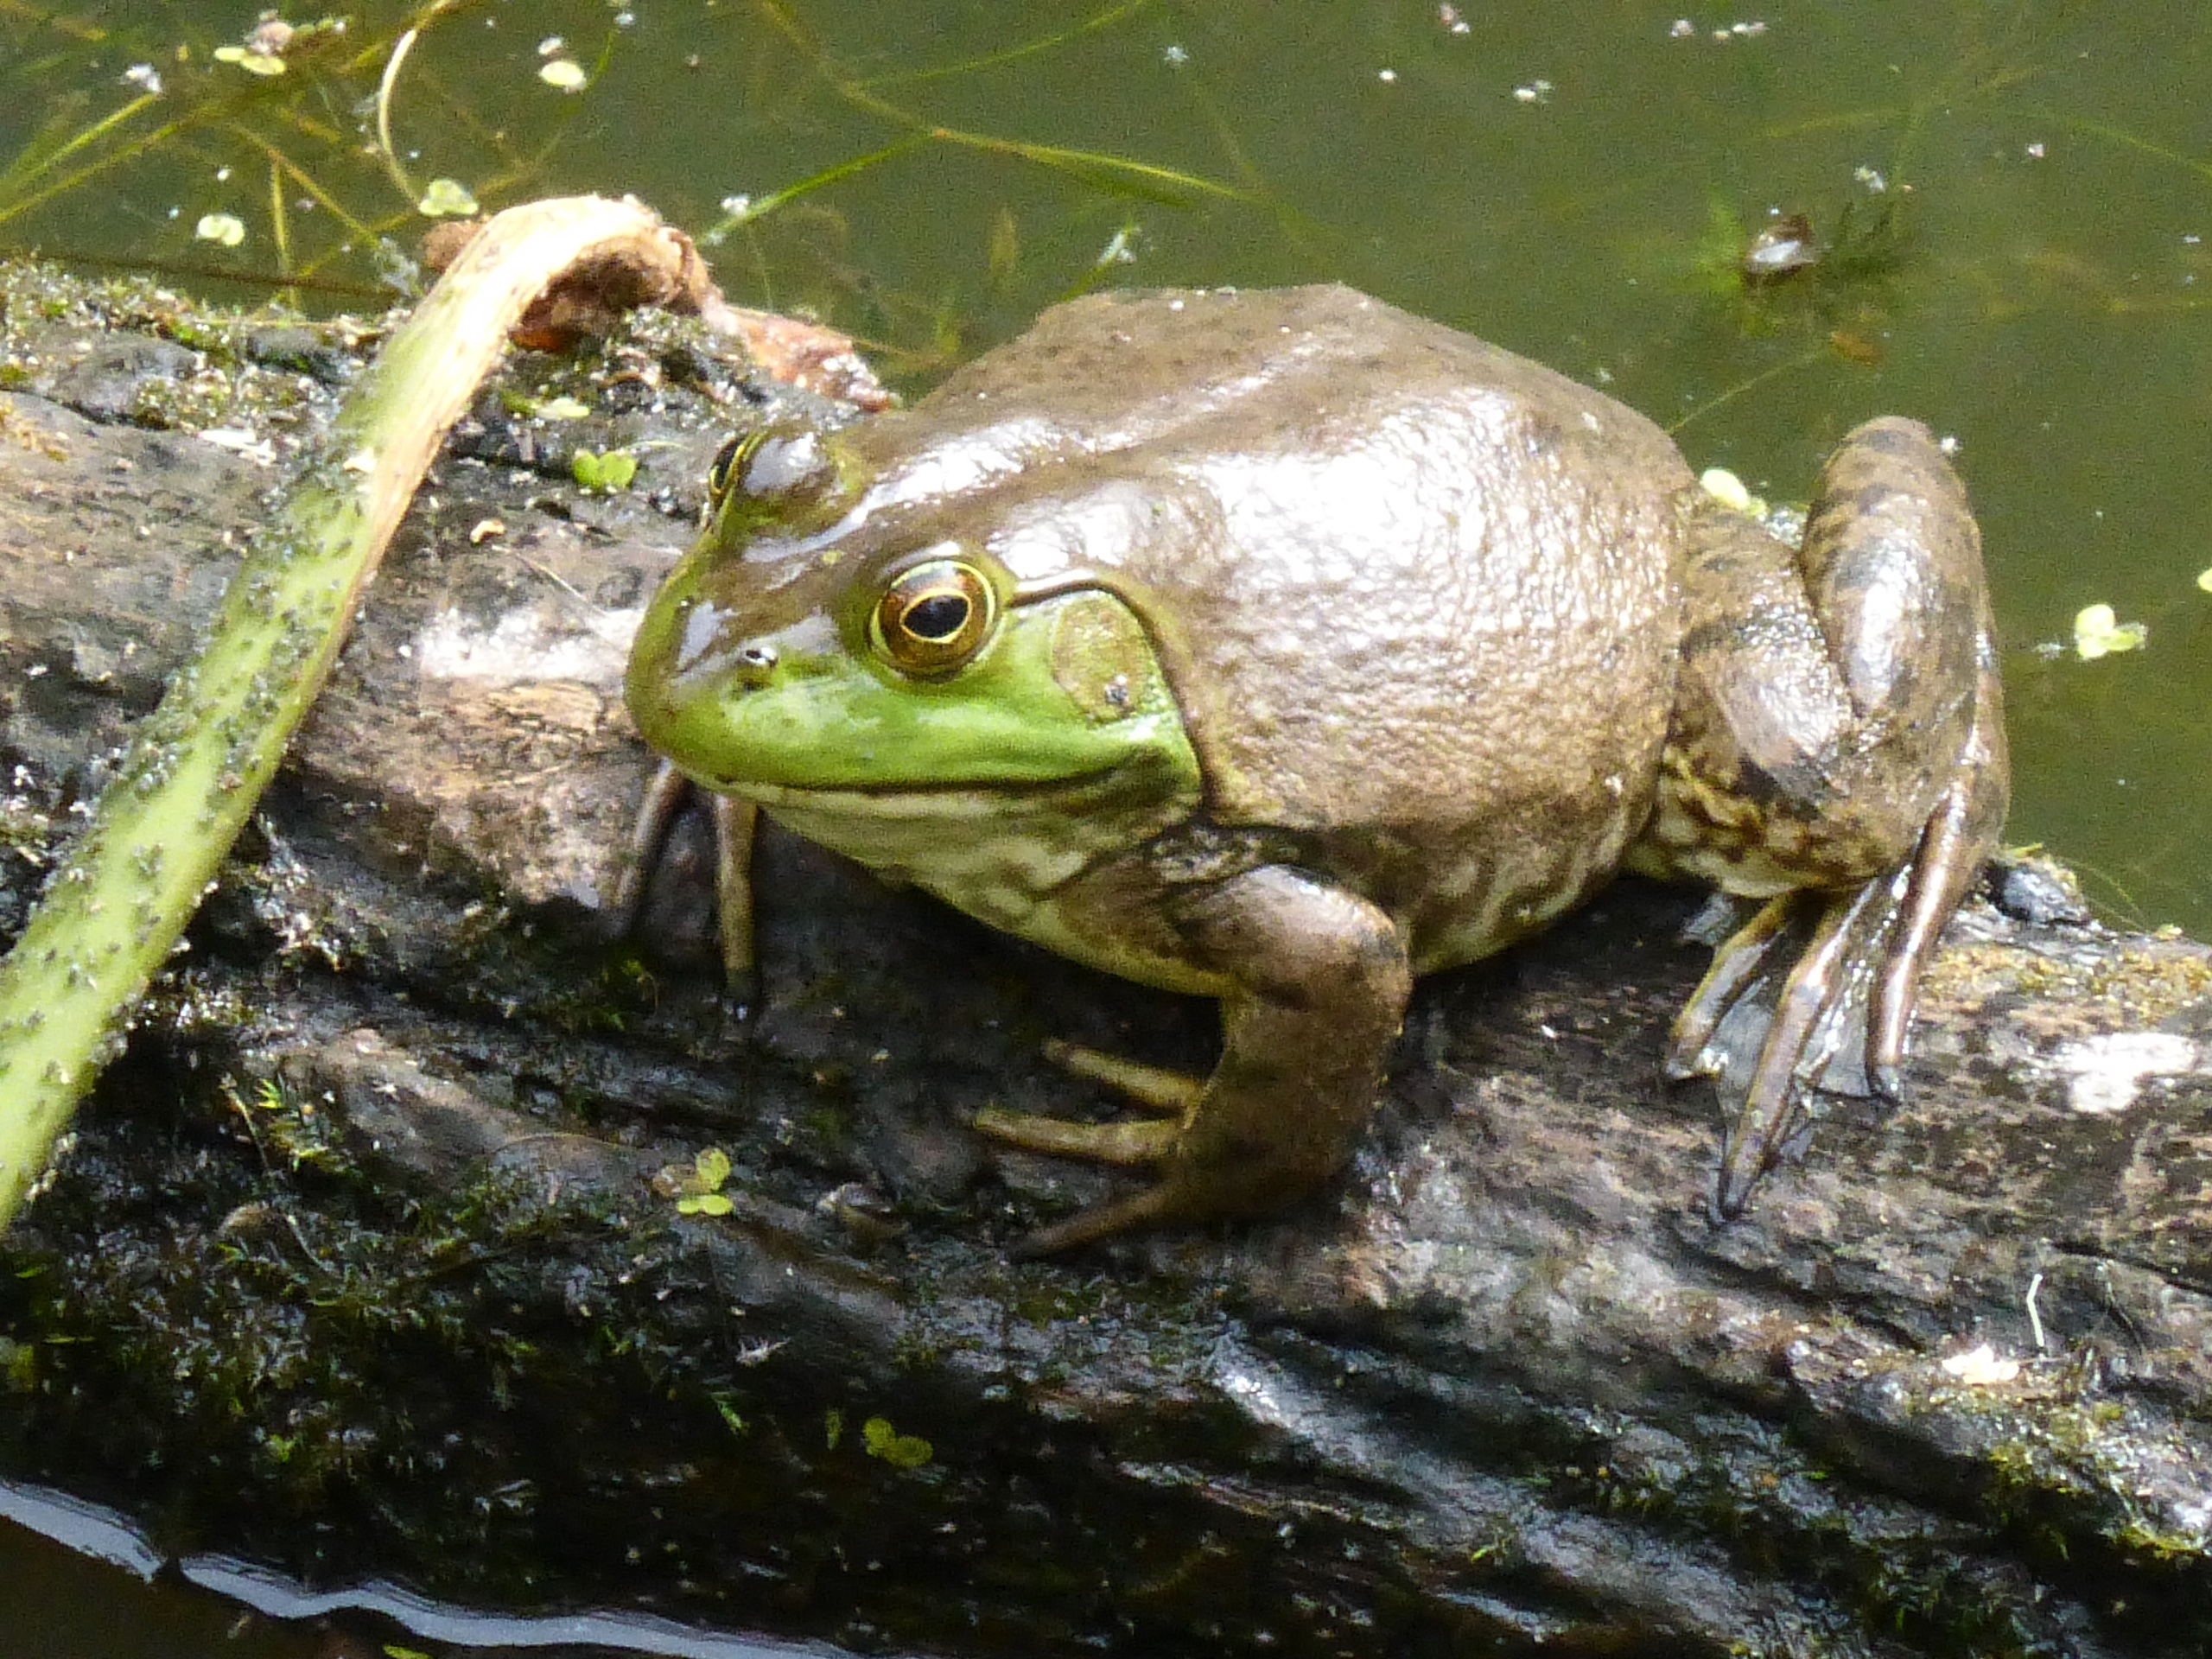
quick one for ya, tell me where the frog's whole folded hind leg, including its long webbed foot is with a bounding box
[1632,418,2008,1214]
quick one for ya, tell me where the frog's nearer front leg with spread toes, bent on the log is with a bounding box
[976,865,1411,1255]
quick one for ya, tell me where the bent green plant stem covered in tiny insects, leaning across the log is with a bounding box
[0,197,696,1225]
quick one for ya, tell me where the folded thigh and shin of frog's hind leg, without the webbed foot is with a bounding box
[1650,418,1986,893]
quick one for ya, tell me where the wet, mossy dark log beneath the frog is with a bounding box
[0,270,2212,1659]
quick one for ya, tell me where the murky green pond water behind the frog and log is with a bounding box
[0,0,2212,1652]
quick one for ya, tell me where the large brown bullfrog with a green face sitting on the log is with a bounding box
[628,288,2006,1249]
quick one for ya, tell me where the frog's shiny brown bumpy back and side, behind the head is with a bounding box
[862,288,1692,967]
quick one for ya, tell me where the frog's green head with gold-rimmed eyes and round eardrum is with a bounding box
[628,431,1197,803]
